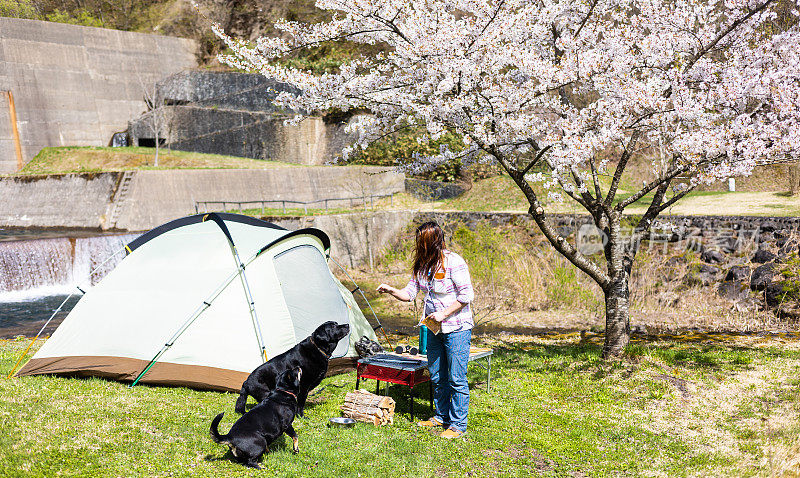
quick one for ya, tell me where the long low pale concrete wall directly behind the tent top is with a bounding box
[0,166,404,231]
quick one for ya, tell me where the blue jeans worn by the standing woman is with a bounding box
[428,329,472,432]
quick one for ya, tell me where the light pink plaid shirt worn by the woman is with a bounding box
[403,250,475,334]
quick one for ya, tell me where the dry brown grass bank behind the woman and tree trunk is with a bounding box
[354,218,798,334]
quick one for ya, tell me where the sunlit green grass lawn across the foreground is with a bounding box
[0,336,800,477]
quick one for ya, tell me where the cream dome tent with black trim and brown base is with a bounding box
[17,213,376,391]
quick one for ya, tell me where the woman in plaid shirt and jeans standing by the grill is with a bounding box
[378,222,475,438]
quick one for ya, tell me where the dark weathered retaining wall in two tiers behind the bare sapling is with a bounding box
[128,71,354,165]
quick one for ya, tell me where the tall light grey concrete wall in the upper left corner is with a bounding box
[0,18,197,173]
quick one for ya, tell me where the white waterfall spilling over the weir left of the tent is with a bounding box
[0,234,138,302]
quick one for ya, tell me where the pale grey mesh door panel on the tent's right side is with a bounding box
[274,245,350,357]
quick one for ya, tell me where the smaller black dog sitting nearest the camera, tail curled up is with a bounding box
[211,368,303,468]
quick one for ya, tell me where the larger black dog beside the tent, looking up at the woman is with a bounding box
[235,321,350,417]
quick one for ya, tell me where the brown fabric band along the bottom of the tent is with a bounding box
[15,356,356,392]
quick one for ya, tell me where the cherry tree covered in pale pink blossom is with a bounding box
[215,0,800,357]
